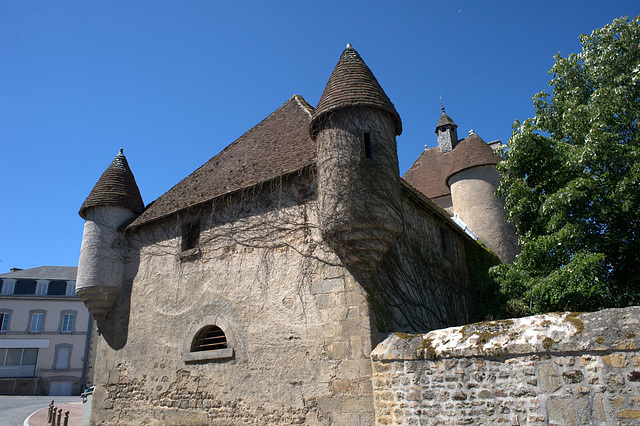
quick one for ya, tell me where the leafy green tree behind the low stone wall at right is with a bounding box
[493,16,640,316]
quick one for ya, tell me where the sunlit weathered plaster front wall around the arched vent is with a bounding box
[92,176,380,424]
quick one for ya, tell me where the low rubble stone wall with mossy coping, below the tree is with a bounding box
[372,307,640,425]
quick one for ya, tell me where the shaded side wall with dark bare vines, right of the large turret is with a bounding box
[366,188,473,333]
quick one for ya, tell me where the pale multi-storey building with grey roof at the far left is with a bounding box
[0,266,92,395]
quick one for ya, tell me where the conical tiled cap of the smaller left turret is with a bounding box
[79,150,144,219]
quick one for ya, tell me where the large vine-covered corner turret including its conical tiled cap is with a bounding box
[310,46,403,273]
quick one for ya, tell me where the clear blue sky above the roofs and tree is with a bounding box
[0,0,640,272]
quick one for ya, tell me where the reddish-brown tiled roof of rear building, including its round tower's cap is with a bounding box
[403,133,500,198]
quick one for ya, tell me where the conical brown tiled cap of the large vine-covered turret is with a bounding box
[309,45,402,140]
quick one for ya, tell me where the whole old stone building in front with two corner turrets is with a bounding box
[77,46,516,424]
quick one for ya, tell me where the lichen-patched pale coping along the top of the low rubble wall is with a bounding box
[371,306,640,361]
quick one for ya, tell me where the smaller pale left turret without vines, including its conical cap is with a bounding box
[76,149,144,321]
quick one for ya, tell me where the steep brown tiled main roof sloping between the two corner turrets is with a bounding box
[129,95,316,228]
